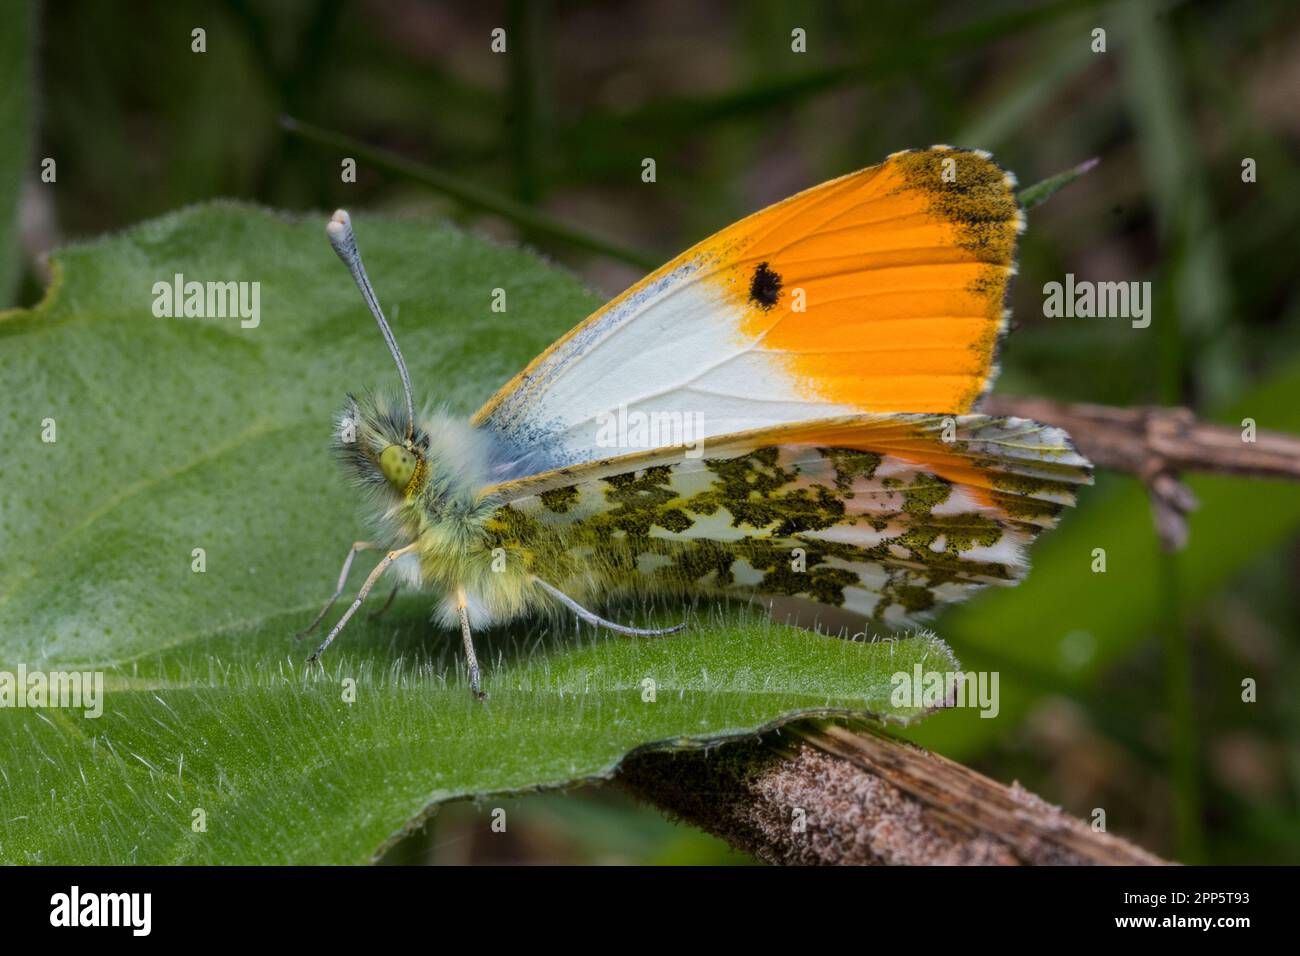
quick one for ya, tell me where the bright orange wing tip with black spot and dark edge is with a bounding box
[698,147,1023,412]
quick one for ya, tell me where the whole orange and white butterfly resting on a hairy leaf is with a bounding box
[295,146,1092,697]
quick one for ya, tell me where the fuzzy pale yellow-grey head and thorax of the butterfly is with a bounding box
[334,393,545,627]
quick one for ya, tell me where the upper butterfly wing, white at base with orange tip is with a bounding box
[473,147,1023,477]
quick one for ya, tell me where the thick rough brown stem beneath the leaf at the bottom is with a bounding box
[618,722,1165,865]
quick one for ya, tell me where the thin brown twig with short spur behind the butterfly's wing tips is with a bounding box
[982,395,1300,550]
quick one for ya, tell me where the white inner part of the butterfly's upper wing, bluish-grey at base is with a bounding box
[480,260,855,480]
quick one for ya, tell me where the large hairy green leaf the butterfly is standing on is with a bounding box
[0,204,956,864]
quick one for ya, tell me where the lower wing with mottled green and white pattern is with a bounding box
[489,415,1092,623]
